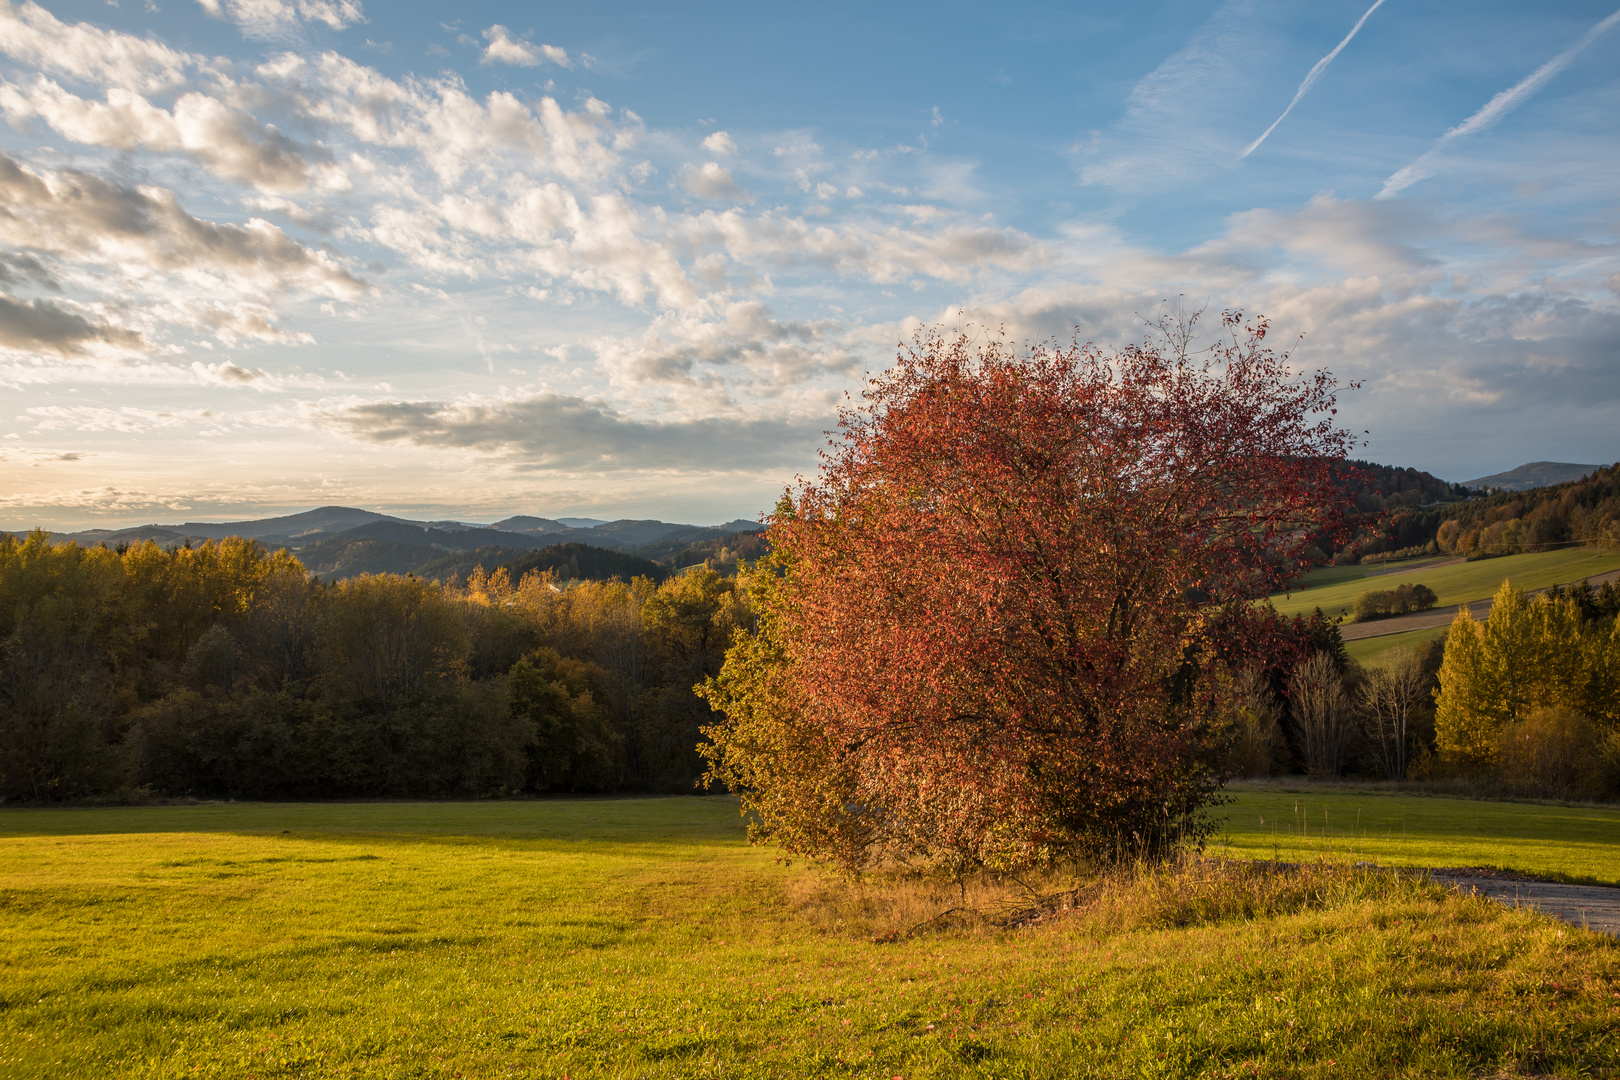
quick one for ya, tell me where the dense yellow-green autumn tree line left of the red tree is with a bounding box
[0,533,750,800]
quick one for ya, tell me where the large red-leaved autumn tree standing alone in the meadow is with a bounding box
[705,313,1351,873]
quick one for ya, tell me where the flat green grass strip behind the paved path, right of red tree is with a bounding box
[1212,782,1620,884]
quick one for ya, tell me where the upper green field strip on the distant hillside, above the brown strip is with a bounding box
[1272,547,1620,615]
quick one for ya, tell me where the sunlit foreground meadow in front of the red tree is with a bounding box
[0,792,1620,1080]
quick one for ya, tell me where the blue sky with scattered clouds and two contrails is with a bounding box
[0,0,1620,529]
